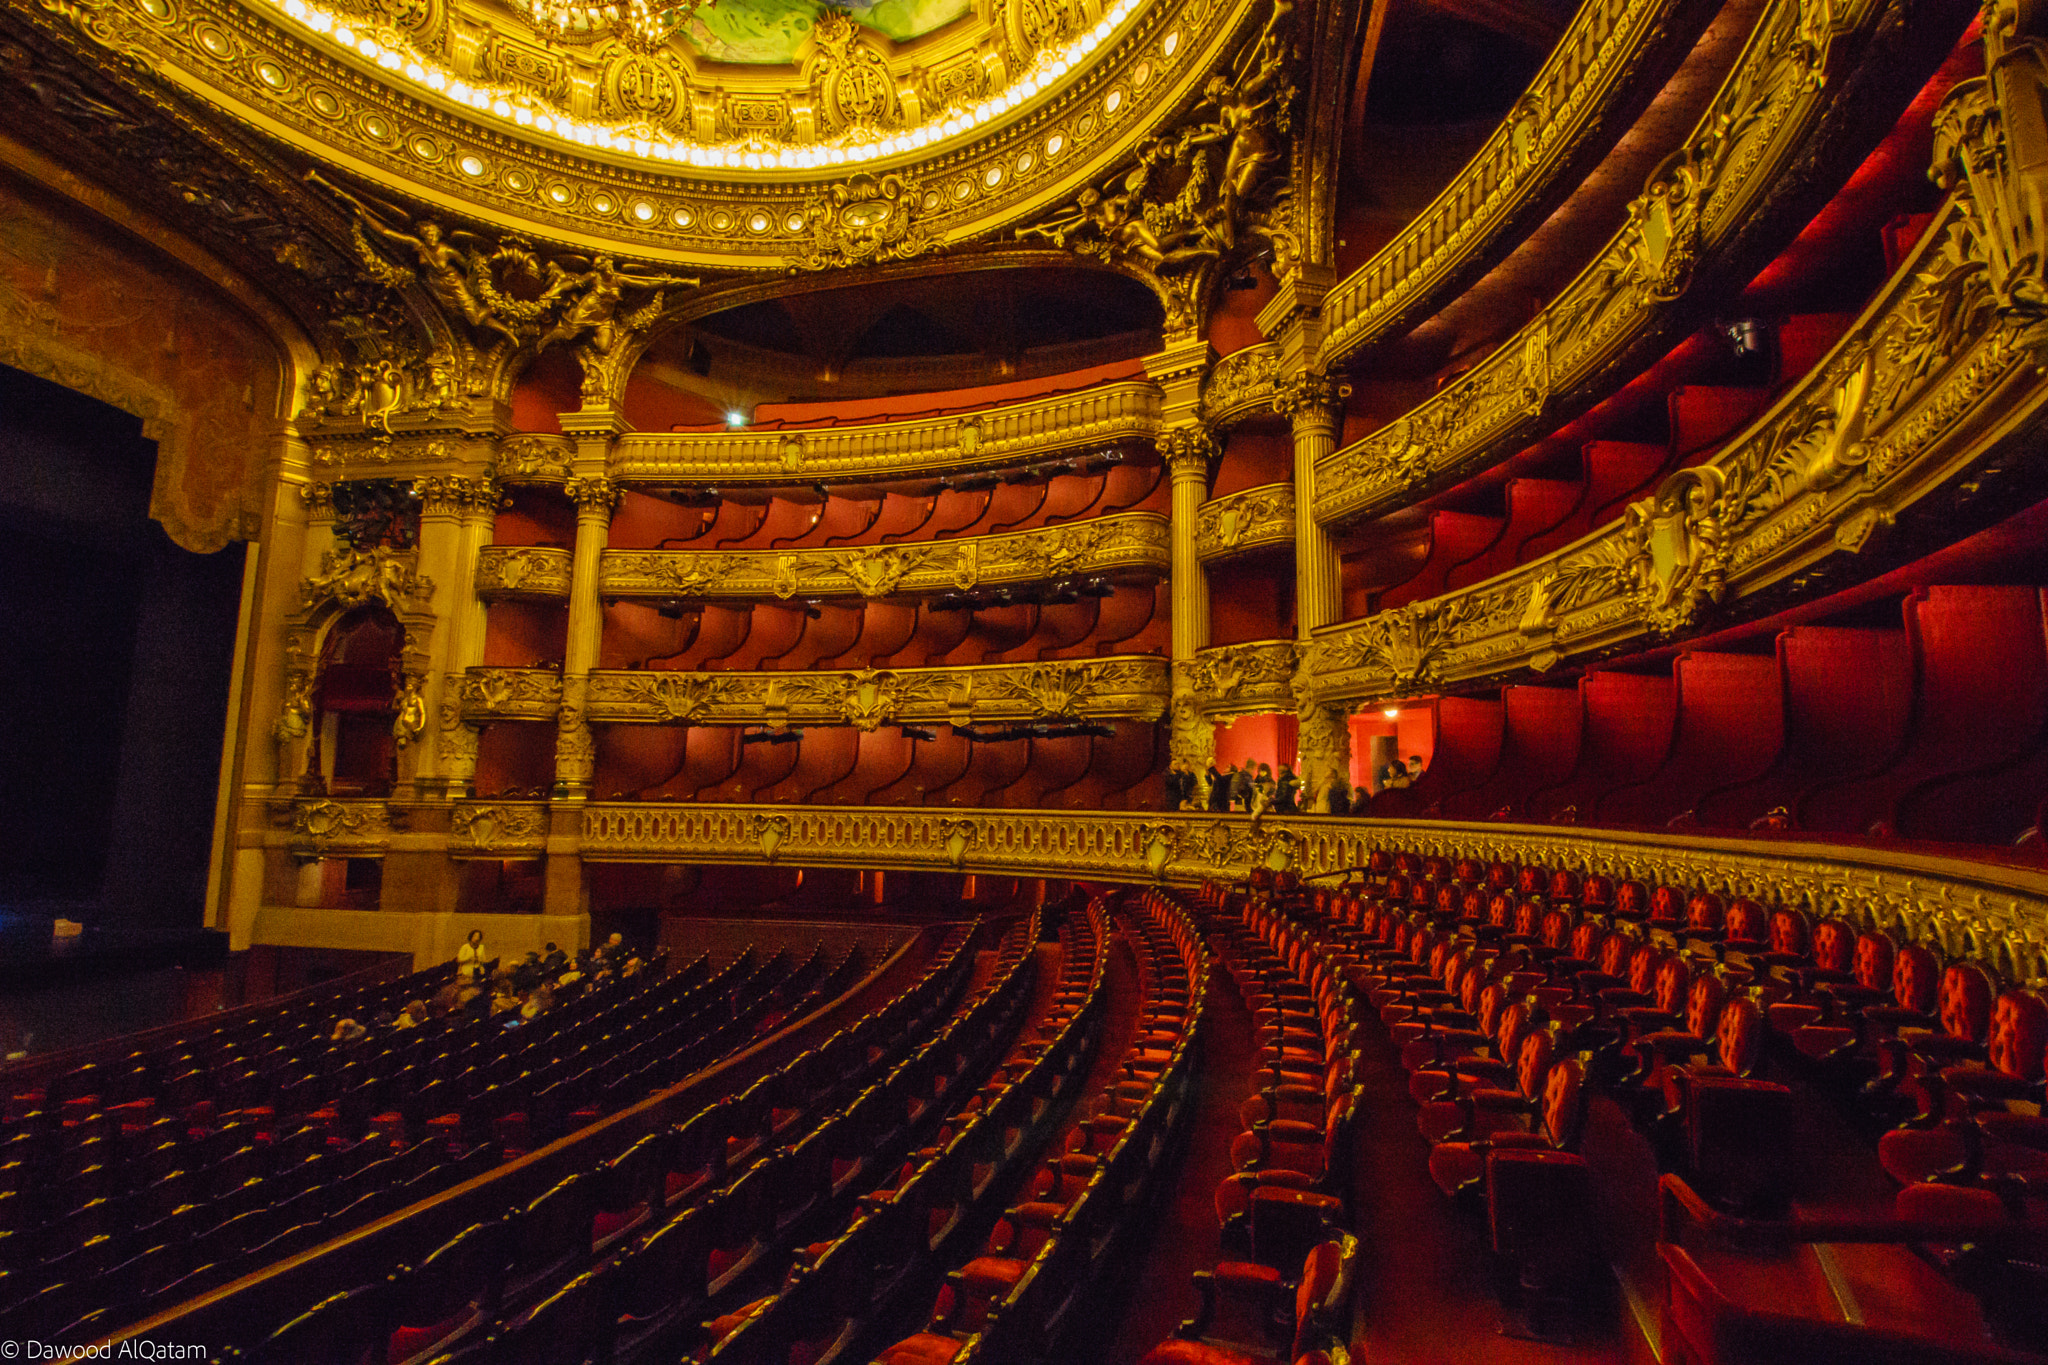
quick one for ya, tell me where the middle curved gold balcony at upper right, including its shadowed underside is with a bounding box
[1315,0,1942,524]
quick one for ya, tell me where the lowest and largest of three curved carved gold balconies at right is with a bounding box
[1311,180,2048,702]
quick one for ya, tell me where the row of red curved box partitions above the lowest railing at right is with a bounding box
[1370,585,2048,843]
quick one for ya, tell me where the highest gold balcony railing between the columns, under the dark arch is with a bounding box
[612,383,1159,487]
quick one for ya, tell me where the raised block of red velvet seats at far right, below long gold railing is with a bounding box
[1286,853,2048,1365]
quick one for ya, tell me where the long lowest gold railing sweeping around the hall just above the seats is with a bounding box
[262,798,2048,980]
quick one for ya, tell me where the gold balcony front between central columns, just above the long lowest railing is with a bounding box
[552,655,1167,731]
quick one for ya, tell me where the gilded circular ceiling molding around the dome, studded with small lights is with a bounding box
[41,0,1264,270]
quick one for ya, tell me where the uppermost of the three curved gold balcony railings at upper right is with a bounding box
[1321,0,1708,366]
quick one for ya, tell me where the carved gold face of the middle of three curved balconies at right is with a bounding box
[1315,0,1888,524]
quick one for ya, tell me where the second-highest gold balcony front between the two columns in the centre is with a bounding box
[593,512,1169,602]
